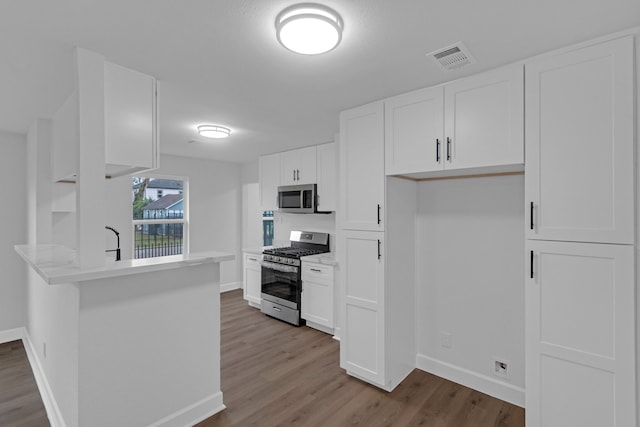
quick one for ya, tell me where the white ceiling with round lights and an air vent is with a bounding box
[0,0,640,162]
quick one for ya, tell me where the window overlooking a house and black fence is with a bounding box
[131,176,187,258]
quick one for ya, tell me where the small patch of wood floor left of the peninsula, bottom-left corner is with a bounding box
[0,341,49,427]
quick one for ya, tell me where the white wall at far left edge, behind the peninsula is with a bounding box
[0,132,27,331]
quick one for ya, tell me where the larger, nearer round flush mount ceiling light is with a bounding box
[276,3,343,55]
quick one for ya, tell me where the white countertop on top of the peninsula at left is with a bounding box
[14,245,235,285]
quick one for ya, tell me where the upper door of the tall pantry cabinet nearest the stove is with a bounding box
[339,102,385,231]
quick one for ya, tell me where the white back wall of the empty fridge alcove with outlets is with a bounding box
[416,175,525,402]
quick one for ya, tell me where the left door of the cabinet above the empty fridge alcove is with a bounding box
[384,86,444,175]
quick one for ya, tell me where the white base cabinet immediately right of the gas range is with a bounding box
[301,260,335,334]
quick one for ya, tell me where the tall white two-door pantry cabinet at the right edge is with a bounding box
[525,36,638,427]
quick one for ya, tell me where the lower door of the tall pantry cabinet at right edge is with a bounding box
[525,240,637,427]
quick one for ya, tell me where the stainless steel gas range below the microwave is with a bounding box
[261,231,329,326]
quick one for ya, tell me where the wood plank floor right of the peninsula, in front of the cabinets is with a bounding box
[198,290,524,427]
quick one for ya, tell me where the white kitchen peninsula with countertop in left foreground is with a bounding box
[15,245,233,426]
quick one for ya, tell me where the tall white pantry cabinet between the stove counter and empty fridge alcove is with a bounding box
[336,101,416,391]
